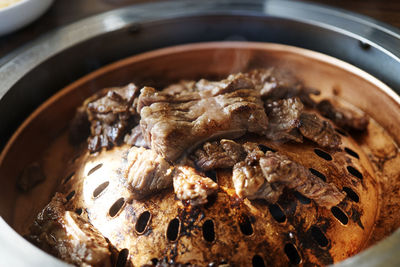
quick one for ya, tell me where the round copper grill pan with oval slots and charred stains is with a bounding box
[2,42,399,266]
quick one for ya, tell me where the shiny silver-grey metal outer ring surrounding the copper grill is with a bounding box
[0,0,400,266]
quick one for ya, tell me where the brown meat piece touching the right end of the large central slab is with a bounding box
[266,97,303,142]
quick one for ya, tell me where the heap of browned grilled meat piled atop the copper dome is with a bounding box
[28,69,368,266]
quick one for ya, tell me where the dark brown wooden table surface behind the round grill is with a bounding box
[0,0,400,58]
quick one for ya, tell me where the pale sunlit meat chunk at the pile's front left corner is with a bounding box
[123,147,173,199]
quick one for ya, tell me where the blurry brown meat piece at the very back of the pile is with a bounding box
[244,68,320,107]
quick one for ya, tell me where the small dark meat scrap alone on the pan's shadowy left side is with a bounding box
[17,162,46,192]
